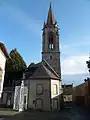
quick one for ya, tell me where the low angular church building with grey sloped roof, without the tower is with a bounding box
[14,60,62,111]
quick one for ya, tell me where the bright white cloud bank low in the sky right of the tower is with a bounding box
[61,55,88,74]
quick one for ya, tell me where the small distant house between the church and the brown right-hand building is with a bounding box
[62,84,73,102]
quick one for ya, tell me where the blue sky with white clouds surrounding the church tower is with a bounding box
[0,0,90,80]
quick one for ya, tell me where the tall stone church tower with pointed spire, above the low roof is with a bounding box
[42,3,61,78]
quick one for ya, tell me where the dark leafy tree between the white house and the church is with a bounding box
[5,49,27,85]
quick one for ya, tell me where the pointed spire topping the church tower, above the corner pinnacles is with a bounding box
[47,2,55,24]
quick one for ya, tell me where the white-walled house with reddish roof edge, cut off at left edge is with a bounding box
[0,42,9,99]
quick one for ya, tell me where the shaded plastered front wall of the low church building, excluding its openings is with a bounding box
[28,79,50,111]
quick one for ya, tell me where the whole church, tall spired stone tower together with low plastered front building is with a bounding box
[13,3,62,111]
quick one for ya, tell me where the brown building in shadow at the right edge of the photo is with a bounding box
[73,78,90,106]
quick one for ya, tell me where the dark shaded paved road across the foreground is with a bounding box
[0,106,90,120]
